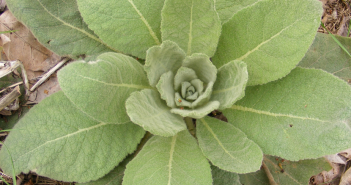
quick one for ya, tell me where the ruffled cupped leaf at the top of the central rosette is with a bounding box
[144,41,185,87]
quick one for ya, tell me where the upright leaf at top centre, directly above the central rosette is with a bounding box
[161,0,221,57]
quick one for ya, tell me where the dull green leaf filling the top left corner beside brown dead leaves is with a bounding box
[6,0,117,58]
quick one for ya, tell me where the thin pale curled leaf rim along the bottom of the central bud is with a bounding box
[171,101,219,119]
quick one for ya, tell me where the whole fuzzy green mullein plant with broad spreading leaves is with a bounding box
[0,0,351,185]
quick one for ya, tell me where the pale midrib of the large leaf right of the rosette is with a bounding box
[230,105,331,123]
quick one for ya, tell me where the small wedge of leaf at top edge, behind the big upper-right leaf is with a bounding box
[216,0,261,24]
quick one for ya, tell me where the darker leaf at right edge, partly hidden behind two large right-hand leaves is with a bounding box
[299,33,351,81]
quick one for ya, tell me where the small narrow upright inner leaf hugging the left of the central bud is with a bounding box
[156,71,175,108]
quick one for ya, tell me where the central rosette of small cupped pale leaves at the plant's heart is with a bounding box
[126,41,248,137]
